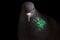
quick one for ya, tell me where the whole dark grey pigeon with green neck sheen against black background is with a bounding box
[18,2,59,40]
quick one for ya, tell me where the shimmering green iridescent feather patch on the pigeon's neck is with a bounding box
[33,17,46,31]
